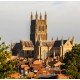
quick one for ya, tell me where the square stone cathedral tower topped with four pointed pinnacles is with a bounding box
[30,12,47,45]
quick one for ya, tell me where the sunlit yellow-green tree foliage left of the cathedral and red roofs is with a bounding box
[0,39,17,78]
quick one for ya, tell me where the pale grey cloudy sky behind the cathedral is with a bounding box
[0,1,80,44]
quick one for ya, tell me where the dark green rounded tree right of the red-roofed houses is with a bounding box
[63,44,80,79]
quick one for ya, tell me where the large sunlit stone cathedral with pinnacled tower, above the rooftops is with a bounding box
[11,12,75,60]
